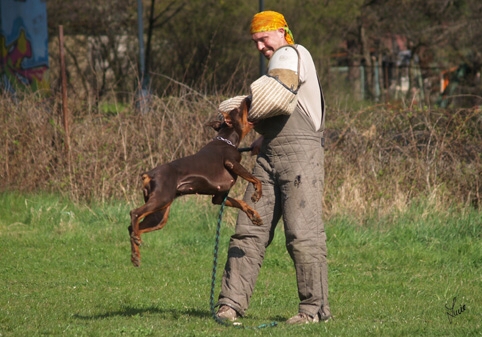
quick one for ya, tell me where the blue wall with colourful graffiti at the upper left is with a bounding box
[0,0,49,93]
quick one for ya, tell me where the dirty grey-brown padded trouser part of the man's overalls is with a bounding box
[218,135,329,316]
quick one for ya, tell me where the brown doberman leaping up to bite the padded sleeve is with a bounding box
[129,100,262,267]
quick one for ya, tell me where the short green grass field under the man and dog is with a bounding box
[0,193,482,337]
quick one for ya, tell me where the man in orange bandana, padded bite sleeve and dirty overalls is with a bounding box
[217,11,331,324]
